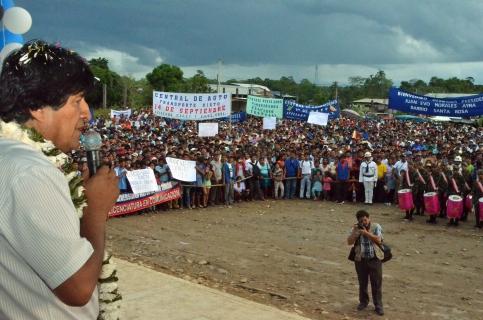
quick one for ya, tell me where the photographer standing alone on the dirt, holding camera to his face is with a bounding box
[347,210,384,316]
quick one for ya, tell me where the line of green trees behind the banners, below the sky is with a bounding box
[89,58,483,108]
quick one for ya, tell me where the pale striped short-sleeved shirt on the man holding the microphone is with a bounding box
[0,139,99,320]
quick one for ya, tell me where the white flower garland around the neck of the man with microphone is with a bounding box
[0,120,122,320]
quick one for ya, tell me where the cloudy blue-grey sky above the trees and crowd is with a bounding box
[14,0,483,84]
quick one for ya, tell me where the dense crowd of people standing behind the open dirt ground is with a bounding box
[76,109,483,227]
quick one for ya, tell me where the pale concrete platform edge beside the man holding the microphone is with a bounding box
[115,259,307,320]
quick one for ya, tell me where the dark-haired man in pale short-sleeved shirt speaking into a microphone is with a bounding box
[0,41,119,320]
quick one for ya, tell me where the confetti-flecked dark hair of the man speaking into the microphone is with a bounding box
[0,40,94,123]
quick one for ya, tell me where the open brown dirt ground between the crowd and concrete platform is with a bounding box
[108,200,483,320]
